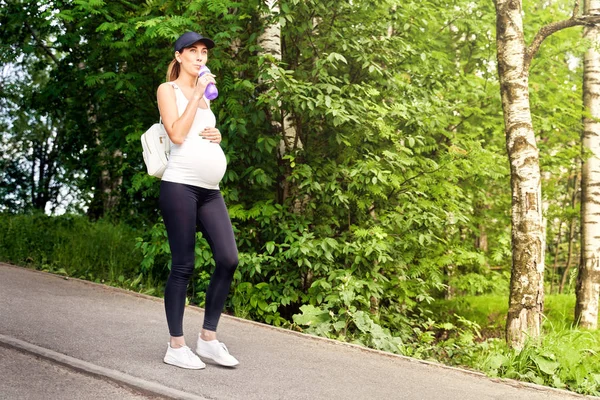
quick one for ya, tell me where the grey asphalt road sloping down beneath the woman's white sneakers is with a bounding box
[0,264,583,400]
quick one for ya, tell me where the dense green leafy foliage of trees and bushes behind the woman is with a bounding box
[0,0,591,392]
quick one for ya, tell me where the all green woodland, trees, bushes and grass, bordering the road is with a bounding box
[0,0,600,395]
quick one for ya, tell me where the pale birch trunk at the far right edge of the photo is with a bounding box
[575,0,600,329]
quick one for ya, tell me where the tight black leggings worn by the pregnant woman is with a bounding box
[159,181,238,337]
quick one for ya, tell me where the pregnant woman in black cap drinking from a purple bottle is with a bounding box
[157,32,239,369]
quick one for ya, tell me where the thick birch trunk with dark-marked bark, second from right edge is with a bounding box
[496,0,545,348]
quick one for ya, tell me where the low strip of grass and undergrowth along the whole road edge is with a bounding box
[0,214,600,396]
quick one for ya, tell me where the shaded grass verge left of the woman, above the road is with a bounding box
[0,214,159,294]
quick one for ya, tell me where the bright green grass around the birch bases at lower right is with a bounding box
[434,294,600,396]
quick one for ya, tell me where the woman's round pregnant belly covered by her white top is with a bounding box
[167,140,227,188]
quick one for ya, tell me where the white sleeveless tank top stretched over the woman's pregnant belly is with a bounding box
[162,82,227,190]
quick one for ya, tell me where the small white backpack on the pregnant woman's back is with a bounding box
[141,120,171,178]
